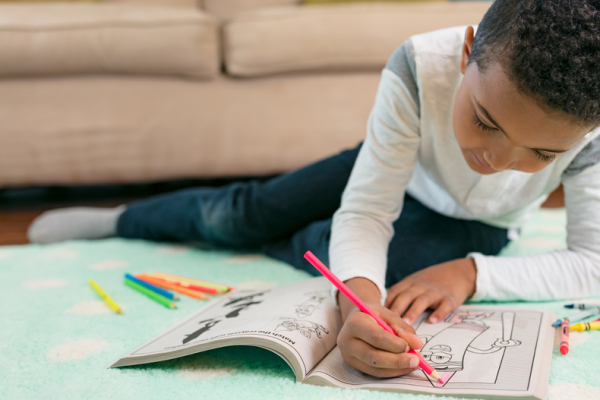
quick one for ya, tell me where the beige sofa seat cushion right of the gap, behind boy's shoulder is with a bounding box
[224,2,491,77]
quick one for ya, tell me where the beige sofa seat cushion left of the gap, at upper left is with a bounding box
[0,3,219,78]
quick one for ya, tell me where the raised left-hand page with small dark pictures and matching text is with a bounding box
[115,277,342,376]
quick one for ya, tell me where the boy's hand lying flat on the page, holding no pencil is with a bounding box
[385,258,477,324]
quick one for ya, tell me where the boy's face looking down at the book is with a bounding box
[453,27,592,175]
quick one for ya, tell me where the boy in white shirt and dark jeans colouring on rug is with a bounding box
[29,0,600,377]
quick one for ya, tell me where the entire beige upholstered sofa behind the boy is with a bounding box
[0,0,489,188]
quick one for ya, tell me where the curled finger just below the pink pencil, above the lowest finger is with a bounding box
[351,313,409,354]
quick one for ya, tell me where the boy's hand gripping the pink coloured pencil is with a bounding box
[337,302,423,378]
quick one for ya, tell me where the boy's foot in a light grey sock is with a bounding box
[27,206,125,244]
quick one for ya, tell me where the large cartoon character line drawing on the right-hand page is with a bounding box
[411,311,521,387]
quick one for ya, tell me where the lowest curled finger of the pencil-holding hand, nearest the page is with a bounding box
[349,340,419,376]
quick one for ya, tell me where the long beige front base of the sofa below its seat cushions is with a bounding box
[0,72,379,186]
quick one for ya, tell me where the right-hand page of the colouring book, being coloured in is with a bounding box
[307,306,553,397]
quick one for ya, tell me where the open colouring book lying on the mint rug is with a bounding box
[111,277,555,399]
